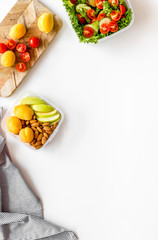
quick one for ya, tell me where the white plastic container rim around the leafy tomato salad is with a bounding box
[63,0,135,44]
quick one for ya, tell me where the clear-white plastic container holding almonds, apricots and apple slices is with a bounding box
[1,91,64,151]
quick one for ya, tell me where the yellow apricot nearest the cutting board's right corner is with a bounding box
[38,13,54,33]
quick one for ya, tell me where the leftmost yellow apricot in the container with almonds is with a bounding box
[7,116,22,134]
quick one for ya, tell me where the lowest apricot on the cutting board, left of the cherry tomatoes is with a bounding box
[1,51,15,67]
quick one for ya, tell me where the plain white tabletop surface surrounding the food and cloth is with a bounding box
[0,0,158,240]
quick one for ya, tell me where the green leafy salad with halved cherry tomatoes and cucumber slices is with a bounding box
[63,0,132,43]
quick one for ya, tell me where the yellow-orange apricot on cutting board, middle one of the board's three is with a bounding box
[9,23,26,39]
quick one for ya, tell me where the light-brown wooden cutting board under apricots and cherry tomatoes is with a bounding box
[0,0,62,97]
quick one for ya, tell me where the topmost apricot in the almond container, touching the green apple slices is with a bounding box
[14,105,34,121]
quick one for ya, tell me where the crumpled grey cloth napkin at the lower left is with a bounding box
[0,108,77,240]
